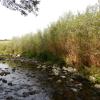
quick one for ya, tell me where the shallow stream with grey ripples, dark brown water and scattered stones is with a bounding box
[0,59,100,100]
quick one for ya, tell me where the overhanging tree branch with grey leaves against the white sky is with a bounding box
[0,0,40,16]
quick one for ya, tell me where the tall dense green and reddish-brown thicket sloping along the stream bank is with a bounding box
[0,5,100,66]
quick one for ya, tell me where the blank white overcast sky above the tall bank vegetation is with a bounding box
[0,0,98,39]
